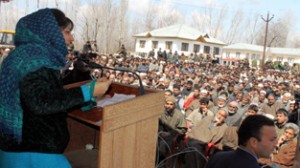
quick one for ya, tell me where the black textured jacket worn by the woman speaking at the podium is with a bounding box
[0,68,84,153]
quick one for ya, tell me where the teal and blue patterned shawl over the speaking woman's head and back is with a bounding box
[0,8,68,143]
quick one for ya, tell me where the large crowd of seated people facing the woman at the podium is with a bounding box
[60,46,300,168]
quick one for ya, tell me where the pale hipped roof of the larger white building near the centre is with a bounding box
[134,24,225,45]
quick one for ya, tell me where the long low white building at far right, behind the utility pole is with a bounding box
[221,43,300,65]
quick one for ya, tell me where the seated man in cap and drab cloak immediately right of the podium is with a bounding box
[158,96,187,159]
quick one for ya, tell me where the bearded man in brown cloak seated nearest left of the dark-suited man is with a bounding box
[185,109,228,168]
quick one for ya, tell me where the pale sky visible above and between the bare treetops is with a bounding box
[0,0,300,39]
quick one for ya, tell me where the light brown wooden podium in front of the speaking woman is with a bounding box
[66,83,164,168]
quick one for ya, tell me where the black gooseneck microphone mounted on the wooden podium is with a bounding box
[85,62,145,95]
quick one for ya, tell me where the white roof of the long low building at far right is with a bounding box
[223,43,300,56]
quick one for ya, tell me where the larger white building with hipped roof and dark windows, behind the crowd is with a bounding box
[133,25,225,57]
